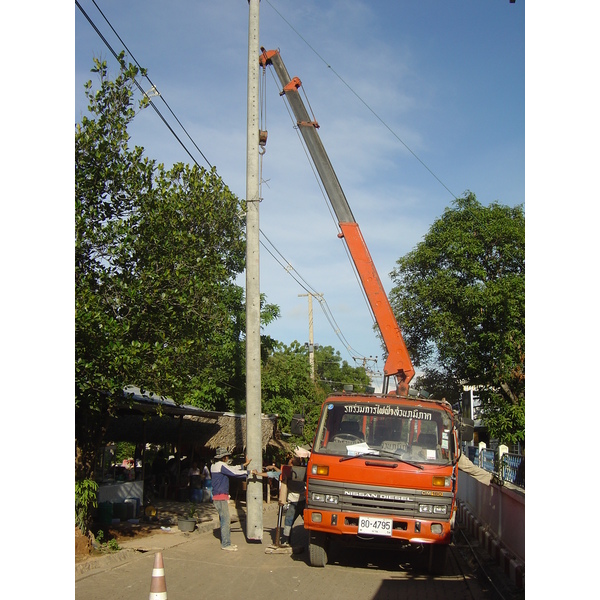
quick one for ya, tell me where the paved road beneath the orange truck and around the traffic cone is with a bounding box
[75,509,524,600]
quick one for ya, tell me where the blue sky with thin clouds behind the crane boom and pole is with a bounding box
[74,0,525,392]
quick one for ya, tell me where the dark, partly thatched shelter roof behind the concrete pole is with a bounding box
[105,387,287,452]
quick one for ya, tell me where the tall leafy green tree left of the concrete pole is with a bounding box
[75,55,247,478]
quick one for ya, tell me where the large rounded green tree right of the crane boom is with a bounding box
[390,192,525,443]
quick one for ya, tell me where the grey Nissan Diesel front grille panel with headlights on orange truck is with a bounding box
[306,478,453,521]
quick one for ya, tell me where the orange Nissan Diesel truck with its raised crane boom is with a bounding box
[259,48,473,573]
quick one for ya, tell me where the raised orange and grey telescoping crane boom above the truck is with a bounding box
[260,48,415,395]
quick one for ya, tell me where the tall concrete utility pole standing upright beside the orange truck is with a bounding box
[246,0,263,541]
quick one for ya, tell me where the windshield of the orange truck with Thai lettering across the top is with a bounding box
[313,399,455,465]
